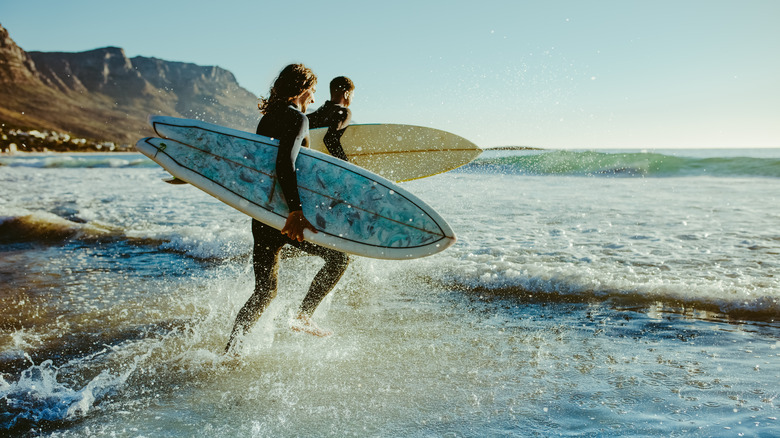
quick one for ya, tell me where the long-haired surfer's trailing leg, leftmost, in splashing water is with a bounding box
[225,219,284,352]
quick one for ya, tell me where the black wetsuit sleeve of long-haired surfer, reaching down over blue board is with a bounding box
[276,114,309,212]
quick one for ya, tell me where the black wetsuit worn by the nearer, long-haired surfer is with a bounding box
[227,106,349,349]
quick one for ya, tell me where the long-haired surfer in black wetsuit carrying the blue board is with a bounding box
[225,64,349,353]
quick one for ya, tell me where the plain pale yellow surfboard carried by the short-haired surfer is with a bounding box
[310,124,482,182]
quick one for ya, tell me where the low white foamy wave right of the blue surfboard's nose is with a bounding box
[417,254,780,321]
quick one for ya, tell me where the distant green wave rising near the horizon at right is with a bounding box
[461,151,780,178]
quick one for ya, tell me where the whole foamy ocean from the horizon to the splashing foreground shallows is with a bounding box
[0,149,780,437]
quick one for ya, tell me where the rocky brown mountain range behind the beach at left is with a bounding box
[0,25,260,144]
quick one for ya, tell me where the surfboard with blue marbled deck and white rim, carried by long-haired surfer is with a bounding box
[141,117,455,260]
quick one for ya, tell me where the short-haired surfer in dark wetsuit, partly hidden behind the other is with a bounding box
[307,76,355,161]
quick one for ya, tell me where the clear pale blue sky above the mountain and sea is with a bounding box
[0,0,780,149]
